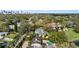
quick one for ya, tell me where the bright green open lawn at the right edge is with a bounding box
[66,28,79,41]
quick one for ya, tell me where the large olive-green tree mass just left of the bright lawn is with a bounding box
[49,31,68,44]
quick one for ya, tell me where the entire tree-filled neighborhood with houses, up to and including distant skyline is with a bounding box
[0,10,79,48]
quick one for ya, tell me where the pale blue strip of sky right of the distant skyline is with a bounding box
[26,10,79,14]
